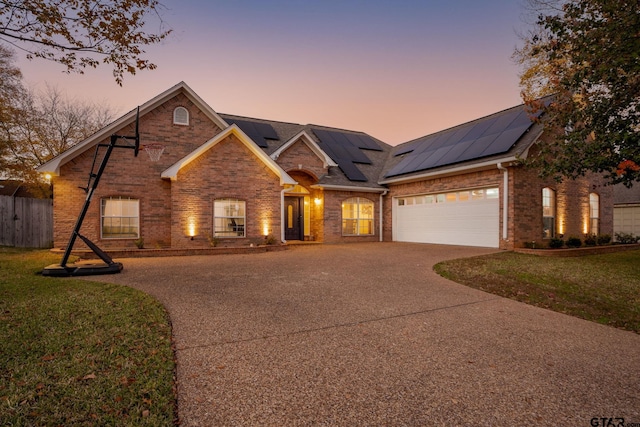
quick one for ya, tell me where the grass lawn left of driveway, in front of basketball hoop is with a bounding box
[0,248,176,426]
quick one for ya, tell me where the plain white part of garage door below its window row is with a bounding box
[394,190,500,247]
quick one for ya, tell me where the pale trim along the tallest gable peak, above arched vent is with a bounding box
[36,82,229,176]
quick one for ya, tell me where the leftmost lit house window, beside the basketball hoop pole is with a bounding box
[100,197,140,239]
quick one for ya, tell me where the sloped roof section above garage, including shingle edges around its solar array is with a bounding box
[383,105,542,182]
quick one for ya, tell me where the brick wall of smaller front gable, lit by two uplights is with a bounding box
[171,135,282,248]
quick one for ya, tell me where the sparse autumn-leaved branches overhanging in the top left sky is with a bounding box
[0,0,171,85]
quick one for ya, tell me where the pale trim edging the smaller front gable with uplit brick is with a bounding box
[161,124,298,185]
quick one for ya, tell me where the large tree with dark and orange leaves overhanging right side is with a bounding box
[514,0,640,186]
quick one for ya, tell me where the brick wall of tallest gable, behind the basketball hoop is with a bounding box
[53,94,220,249]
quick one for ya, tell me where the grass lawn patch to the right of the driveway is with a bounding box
[435,250,640,333]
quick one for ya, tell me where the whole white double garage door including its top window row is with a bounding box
[393,188,500,248]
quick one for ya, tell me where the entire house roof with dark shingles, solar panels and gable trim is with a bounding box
[38,82,542,191]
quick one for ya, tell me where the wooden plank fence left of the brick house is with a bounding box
[0,196,53,248]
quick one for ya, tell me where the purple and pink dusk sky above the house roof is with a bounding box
[17,0,525,145]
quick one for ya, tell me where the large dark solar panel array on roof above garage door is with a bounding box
[386,106,532,177]
